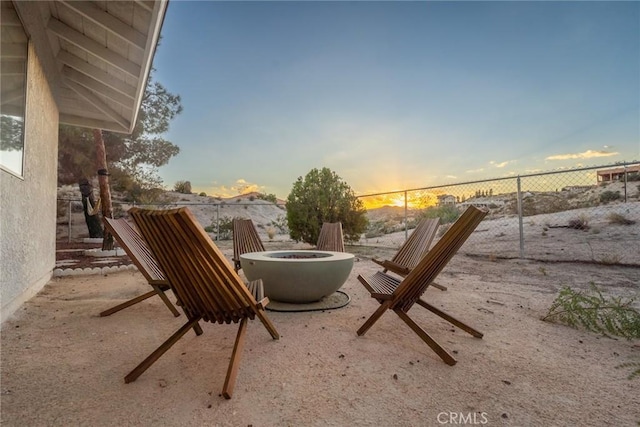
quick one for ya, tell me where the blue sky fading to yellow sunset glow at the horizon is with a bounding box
[153,0,640,199]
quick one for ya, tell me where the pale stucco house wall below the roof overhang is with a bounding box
[0,45,58,322]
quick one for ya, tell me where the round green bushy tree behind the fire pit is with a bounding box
[287,168,368,244]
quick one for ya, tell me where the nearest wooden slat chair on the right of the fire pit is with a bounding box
[357,206,487,365]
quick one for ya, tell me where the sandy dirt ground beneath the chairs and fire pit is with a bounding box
[0,239,640,426]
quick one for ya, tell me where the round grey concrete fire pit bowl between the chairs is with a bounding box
[240,250,354,304]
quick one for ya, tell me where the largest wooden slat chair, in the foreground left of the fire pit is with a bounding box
[125,207,280,399]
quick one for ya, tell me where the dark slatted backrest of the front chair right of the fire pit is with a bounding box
[394,206,487,311]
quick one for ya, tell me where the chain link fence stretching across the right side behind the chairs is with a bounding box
[359,163,640,266]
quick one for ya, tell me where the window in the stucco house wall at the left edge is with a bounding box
[0,1,28,176]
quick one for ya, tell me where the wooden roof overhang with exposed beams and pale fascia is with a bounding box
[13,0,168,134]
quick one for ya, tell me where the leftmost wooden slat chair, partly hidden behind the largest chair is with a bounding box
[100,217,180,317]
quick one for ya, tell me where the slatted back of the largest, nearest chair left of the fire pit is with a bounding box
[129,208,257,323]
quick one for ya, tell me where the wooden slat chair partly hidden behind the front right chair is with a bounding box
[372,218,447,291]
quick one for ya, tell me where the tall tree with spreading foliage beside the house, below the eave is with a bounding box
[58,70,182,197]
